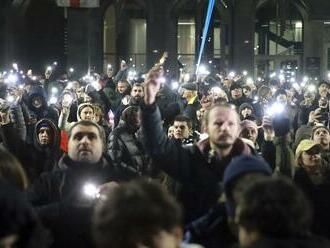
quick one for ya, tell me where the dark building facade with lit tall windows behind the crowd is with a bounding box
[0,0,330,78]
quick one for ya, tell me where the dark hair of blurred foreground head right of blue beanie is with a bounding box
[237,178,312,238]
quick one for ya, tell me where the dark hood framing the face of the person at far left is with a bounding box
[33,119,60,151]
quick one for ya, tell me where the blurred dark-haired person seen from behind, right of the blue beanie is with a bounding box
[235,178,330,248]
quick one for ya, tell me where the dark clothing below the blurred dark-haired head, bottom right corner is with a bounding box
[249,236,330,248]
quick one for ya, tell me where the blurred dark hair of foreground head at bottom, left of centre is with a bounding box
[92,180,182,248]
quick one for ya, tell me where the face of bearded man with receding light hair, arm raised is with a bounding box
[206,107,240,148]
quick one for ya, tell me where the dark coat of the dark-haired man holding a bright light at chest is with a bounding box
[28,156,118,247]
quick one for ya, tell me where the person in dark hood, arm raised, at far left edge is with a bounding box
[0,101,60,182]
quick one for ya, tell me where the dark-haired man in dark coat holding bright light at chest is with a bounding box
[28,121,118,247]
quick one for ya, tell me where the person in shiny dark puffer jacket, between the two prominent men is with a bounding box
[107,106,151,179]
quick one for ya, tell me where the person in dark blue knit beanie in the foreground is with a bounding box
[185,155,272,248]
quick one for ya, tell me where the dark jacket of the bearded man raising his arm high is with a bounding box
[141,104,251,221]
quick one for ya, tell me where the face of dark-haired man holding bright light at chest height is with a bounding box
[68,125,103,163]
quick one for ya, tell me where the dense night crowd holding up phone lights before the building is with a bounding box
[0,54,330,248]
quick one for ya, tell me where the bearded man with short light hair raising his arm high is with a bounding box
[141,68,250,223]
